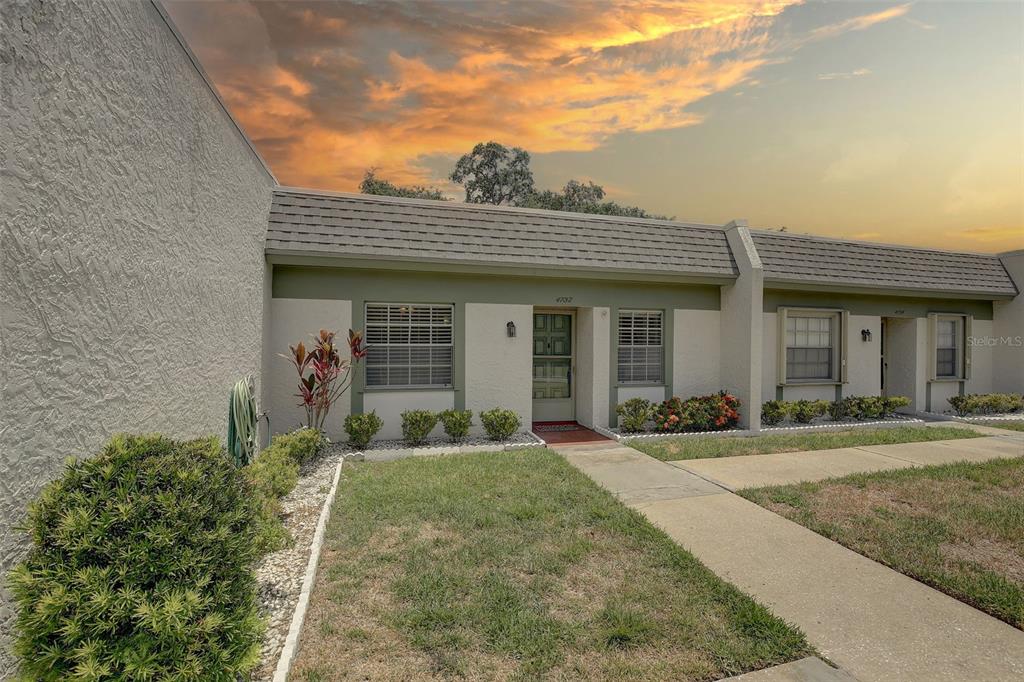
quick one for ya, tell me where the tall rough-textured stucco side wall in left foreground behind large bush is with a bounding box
[0,1,272,659]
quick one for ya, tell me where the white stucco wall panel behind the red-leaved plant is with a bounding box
[263,298,352,440]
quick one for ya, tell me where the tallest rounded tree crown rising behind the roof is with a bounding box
[449,142,534,206]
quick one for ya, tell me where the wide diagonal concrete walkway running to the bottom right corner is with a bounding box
[555,443,1024,682]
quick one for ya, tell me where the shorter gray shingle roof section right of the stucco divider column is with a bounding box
[751,230,1017,296]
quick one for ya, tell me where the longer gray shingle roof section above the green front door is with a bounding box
[266,188,736,279]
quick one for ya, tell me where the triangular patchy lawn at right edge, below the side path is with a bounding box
[739,458,1024,630]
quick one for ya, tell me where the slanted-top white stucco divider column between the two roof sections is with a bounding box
[721,220,764,431]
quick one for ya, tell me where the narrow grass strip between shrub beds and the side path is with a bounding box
[626,426,982,462]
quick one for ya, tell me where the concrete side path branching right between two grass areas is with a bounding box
[669,431,1024,491]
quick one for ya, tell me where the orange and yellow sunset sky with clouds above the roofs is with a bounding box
[165,0,1024,252]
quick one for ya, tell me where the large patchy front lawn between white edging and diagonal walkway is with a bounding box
[292,449,810,681]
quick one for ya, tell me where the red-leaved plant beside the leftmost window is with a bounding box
[282,329,367,431]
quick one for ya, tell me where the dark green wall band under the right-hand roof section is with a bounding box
[764,289,992,319]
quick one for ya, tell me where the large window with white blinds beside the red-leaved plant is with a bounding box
[366,303,455,387]
